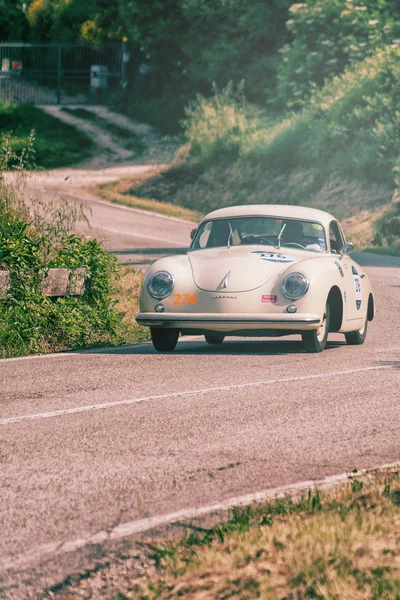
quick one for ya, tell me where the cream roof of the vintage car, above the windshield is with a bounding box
[202,204,337,227]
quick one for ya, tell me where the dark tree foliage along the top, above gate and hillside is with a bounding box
[6,0,400,113]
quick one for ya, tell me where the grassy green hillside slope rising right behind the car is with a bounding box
[121,47,400,252]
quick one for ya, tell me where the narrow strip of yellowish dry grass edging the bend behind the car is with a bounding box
[97,175,202,223]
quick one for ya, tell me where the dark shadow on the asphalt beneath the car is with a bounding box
[78,340,347,356]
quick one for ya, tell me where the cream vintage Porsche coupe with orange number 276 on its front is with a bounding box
[137,205,375,352]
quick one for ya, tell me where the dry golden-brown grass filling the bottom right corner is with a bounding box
[128,474,400,600]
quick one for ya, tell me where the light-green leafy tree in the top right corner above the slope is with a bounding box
[277,0,400,106]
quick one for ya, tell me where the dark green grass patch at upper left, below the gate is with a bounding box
[0,102,94,169]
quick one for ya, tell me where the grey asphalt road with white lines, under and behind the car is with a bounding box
[0,196,400,599]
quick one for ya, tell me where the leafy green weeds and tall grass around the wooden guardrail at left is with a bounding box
[0,137,138,357]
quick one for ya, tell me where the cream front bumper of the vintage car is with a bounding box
[136,312,321,332]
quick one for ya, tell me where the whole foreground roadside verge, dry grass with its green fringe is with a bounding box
[46,469,400,600]
